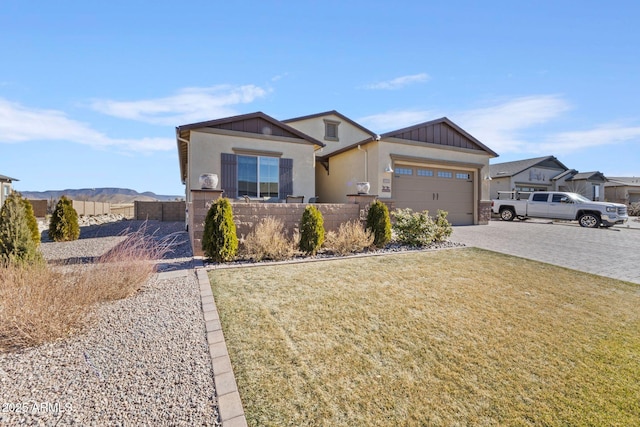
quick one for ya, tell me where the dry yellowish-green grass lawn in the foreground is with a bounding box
[210,248,640,426]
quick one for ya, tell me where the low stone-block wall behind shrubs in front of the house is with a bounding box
[188,190,376,256]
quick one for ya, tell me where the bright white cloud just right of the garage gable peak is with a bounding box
[452,95,570,153]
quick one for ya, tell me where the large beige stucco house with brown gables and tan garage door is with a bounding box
[176,111,498,225]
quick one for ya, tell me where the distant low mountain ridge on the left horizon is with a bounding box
[20,188,184,203]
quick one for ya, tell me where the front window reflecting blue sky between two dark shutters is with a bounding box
[238,156,279,197]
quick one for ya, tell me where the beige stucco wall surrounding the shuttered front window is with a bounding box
[187,129,315,201]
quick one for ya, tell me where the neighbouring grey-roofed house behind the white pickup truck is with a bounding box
[490,156,607,201]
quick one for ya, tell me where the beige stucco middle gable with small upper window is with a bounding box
[287,114,371,156]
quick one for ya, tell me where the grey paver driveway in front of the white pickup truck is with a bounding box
[451,220,640,284]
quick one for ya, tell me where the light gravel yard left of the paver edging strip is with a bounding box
[0,221,219,426]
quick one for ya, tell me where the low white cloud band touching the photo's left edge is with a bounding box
[0,98,175,151]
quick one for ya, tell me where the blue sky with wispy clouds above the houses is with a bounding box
[0,0,640,195]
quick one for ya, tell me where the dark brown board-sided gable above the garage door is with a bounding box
[381,117,498,157]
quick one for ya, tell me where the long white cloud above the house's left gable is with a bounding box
[91,85,269,126]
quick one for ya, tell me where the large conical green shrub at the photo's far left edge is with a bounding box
[0,192,44,266]
